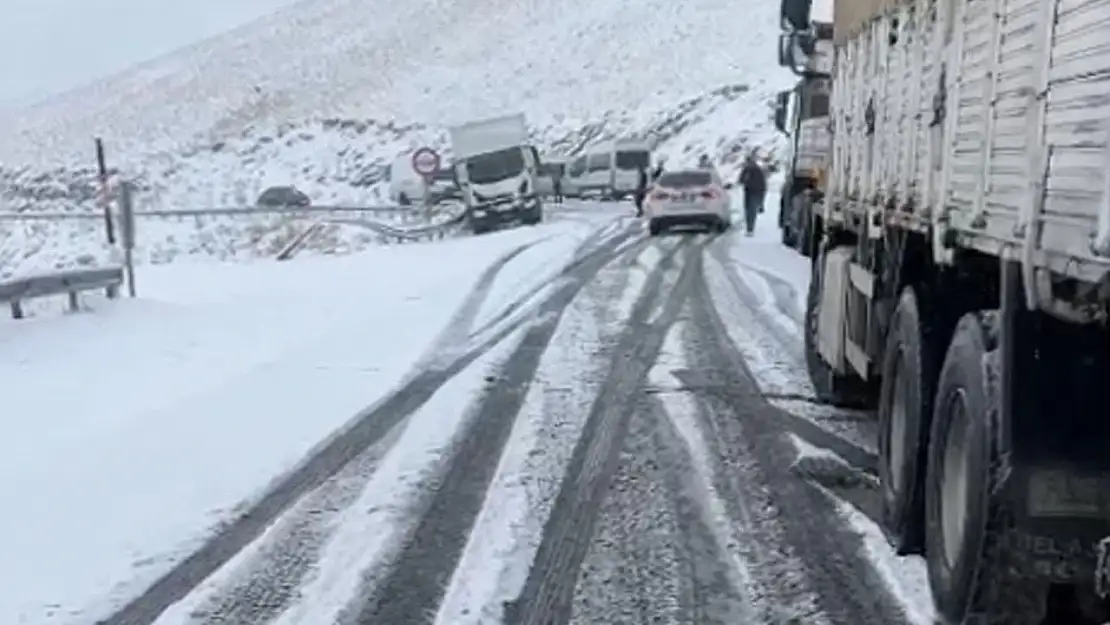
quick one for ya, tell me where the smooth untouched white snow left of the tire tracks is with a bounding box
[0,207,630,623]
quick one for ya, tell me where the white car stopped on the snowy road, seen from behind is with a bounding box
[644,169,733,236]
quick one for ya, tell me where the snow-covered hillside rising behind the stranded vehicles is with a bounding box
[0,0,791,273]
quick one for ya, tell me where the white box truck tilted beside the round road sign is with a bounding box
[450,114,543,234]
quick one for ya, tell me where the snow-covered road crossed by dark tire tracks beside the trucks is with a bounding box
[0,204,931,625]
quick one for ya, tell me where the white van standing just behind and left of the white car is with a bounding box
[565,140,652,200]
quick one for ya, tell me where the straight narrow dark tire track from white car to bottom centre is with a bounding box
[504,235,715,625]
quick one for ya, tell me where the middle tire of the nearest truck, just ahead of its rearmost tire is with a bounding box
[878,286,942,555]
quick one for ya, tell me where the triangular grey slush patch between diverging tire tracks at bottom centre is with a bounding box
[571,395,754,625]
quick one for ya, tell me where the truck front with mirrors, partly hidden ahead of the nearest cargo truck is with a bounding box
[775,0,833,255]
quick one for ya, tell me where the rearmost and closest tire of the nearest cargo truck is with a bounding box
[925,313,1048,625]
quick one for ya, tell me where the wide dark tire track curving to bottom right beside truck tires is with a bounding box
[677,265,907,625]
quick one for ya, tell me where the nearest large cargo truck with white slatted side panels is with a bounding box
[783,0,1110,625]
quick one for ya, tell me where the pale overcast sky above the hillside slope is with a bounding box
[0,0,296,108]
